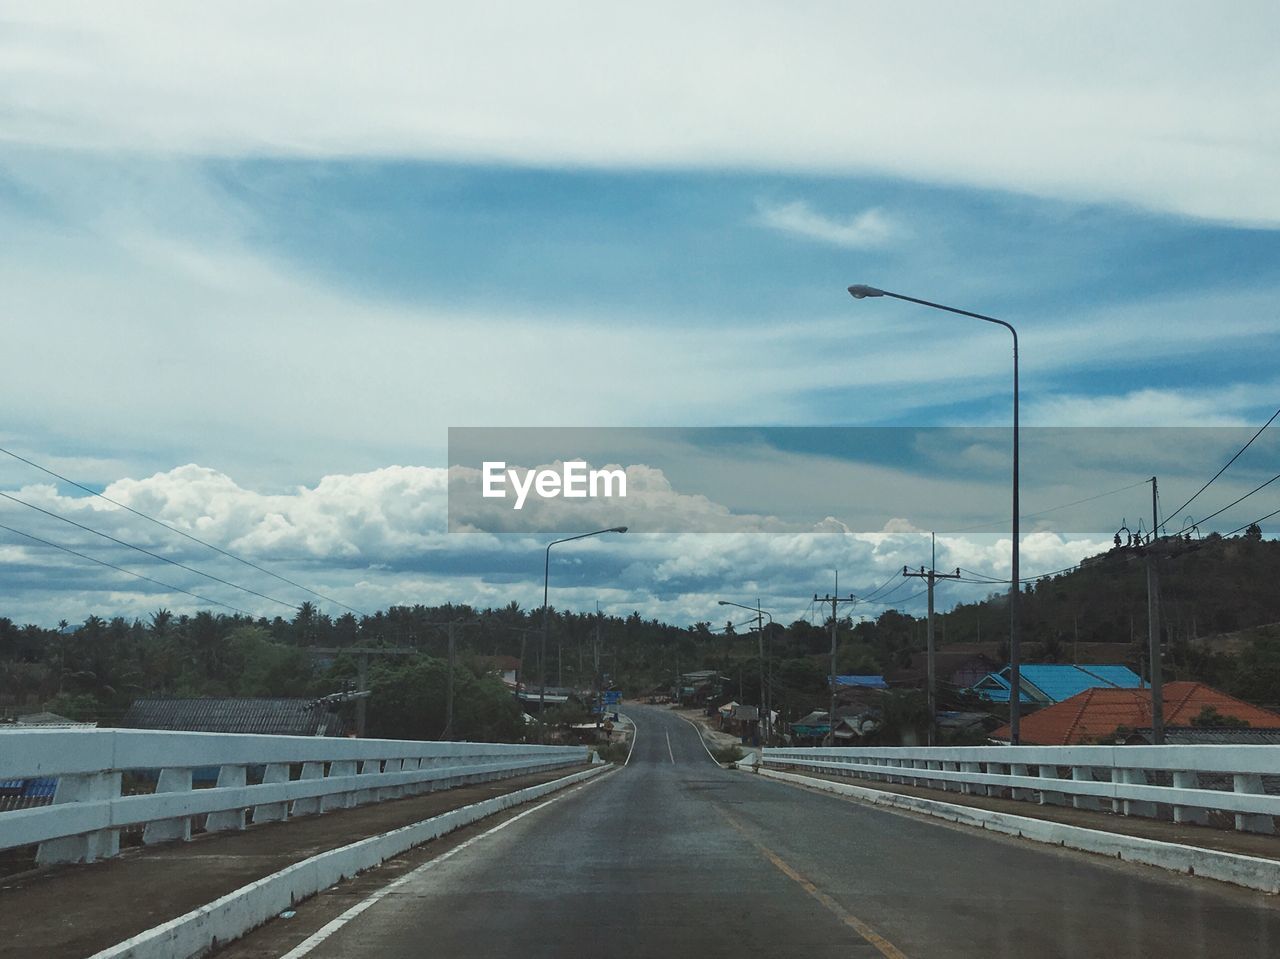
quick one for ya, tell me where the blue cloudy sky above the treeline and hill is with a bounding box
[0,0,1280,625]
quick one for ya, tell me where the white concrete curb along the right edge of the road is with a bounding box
[759,768,1280,892]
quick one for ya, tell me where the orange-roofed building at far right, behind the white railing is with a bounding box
[991,681,1280,746]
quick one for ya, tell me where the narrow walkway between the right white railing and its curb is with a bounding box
[762,768,1280,862]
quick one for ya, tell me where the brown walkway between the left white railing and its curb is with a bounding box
[0,766,585,959]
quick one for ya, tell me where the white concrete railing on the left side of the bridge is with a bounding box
[0,730,590,864]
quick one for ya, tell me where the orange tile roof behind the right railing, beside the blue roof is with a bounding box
[991,681,1280,746]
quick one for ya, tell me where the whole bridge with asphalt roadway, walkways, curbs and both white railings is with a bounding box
[0,705,1280,959]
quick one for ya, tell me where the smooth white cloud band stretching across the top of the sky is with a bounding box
[0,0,1280,224]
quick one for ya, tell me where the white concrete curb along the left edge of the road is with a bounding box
[91,764,613,959]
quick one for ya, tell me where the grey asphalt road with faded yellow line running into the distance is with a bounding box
[264,707,1280,959]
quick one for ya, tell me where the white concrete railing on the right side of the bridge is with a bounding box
[763,745,1280,834]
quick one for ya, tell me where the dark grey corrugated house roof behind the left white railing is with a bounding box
[120,698,346,736]
